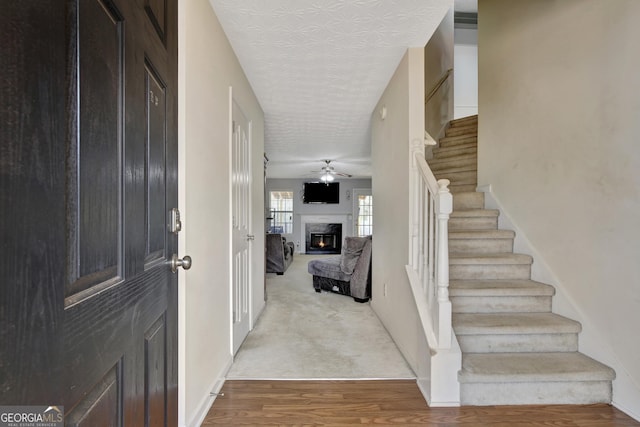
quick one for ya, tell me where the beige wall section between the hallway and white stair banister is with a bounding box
[371,48,428,372]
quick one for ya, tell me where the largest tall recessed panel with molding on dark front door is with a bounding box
[65,0,125,302]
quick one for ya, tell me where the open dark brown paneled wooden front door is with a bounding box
[0,0,178,426]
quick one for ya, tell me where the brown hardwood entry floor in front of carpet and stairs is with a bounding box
[202,380,640,427]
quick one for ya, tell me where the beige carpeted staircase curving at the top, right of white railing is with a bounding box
[428,116,615,405]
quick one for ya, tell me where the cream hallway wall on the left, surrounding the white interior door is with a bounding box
[179,0,264,426]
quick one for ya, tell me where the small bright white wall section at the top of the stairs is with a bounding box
[453,28,478,119]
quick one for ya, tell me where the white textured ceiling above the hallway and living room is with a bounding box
[210,0,456,178]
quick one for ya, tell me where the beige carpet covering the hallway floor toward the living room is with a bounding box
[227,254,415,379]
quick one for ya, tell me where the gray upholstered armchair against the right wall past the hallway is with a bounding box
[307,236,372,302]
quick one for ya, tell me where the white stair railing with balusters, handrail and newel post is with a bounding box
[407,142,453,350]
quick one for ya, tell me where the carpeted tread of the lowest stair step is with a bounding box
[458,352,616,383]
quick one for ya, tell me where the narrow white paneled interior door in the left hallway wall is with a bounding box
[231,101,253,354]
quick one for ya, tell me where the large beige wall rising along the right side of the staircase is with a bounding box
[478,0,640,418]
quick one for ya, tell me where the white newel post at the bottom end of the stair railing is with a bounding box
[436,179,453,348]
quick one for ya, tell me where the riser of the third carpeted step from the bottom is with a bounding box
[451,296,551,313]
